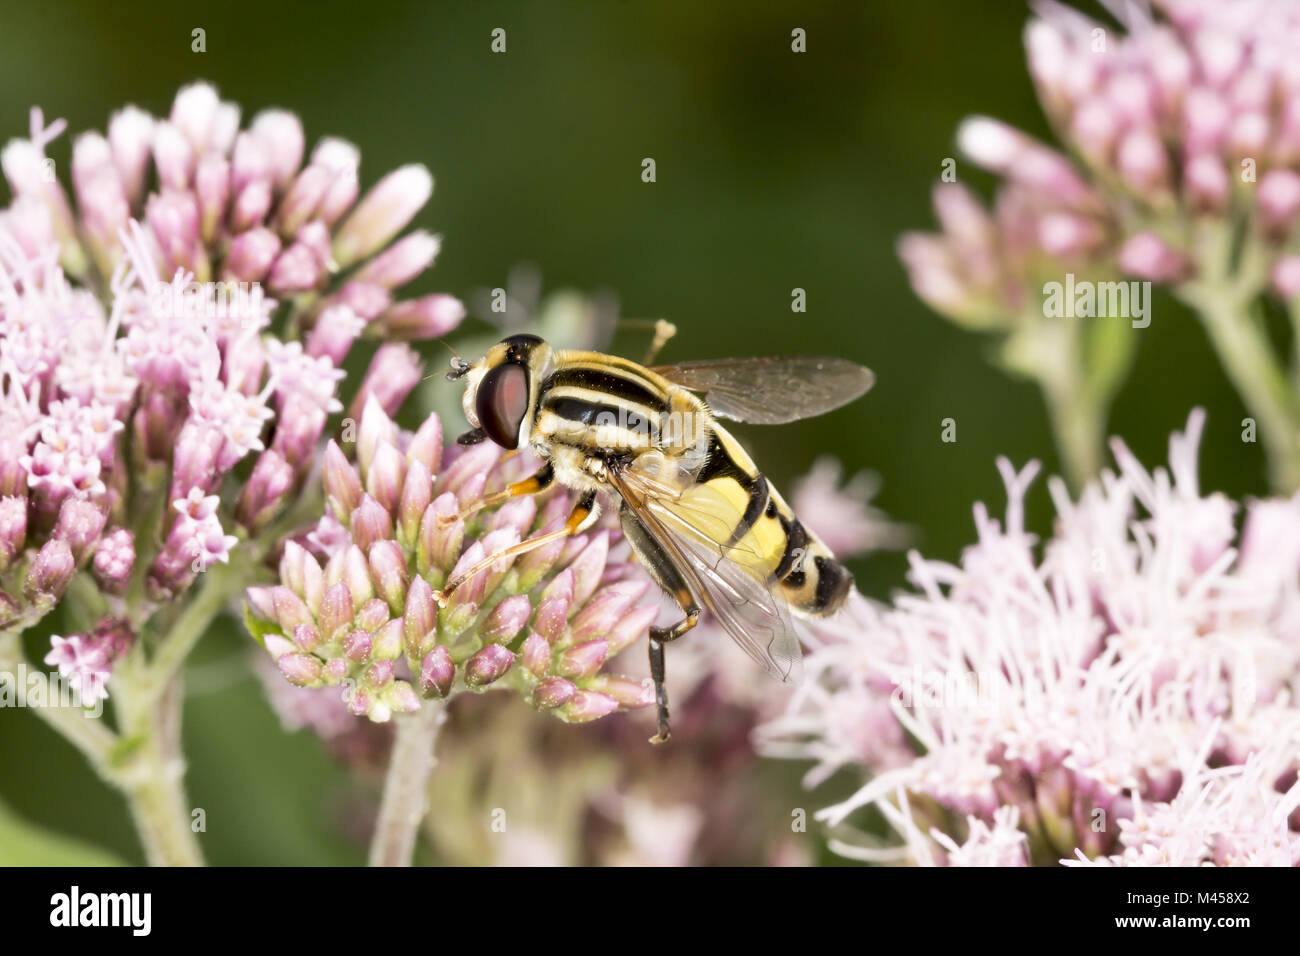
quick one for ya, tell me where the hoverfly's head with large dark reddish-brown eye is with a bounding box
[447,334,551,449]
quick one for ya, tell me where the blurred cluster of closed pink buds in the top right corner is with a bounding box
[900,0,1300,325]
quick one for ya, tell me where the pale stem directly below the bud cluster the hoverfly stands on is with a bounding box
[371,701,446,866]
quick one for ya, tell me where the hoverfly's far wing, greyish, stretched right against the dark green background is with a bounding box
[651,355,875,425]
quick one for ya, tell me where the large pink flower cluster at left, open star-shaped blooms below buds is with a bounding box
[0,83,464,702]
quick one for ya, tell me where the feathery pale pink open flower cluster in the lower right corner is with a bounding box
[763,411,1300,865]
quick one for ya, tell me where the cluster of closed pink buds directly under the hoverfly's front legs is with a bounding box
[248,395,658,723]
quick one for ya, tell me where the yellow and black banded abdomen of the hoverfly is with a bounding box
[684,424,853,617]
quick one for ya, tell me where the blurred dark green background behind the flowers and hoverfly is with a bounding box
[0,0,1265,864]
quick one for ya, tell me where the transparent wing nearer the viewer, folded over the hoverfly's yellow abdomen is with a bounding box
[610,455,802,682]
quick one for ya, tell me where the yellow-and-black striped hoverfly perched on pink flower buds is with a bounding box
[437,326,874,743]
